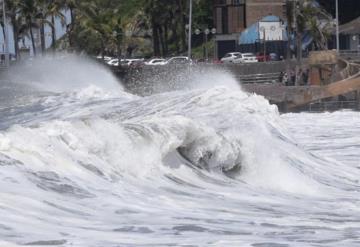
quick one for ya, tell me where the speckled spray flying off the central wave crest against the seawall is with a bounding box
[124,64,241,96]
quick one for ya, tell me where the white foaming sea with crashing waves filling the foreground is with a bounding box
[0,57,360,247]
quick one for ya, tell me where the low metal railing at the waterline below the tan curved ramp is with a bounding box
[308,100,360,112]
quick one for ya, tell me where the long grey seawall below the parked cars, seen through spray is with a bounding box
[112,61,294,95]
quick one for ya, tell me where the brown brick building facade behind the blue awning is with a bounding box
[214,0,286,58]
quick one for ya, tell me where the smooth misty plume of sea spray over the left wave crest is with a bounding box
[4,54,123,94]
